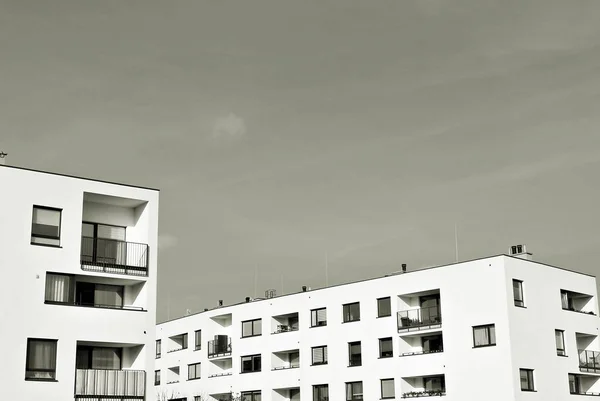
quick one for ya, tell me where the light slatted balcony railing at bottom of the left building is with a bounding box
[75,369,146,400]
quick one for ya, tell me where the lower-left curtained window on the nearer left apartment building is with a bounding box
[25,338,58,380]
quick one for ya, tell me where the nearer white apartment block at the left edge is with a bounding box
[0,165,158,401]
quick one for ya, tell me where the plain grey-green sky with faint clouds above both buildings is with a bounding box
[0,0,600,321]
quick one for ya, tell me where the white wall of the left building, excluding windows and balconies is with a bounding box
[0,166,158,401]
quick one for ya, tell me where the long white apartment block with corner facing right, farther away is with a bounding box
[154,247,600,401]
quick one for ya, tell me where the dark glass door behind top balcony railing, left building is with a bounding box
[81,222,127,266]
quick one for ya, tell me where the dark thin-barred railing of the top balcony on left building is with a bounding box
[81,237,148,276]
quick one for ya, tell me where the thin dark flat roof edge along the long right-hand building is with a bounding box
[156,253,596,326]
